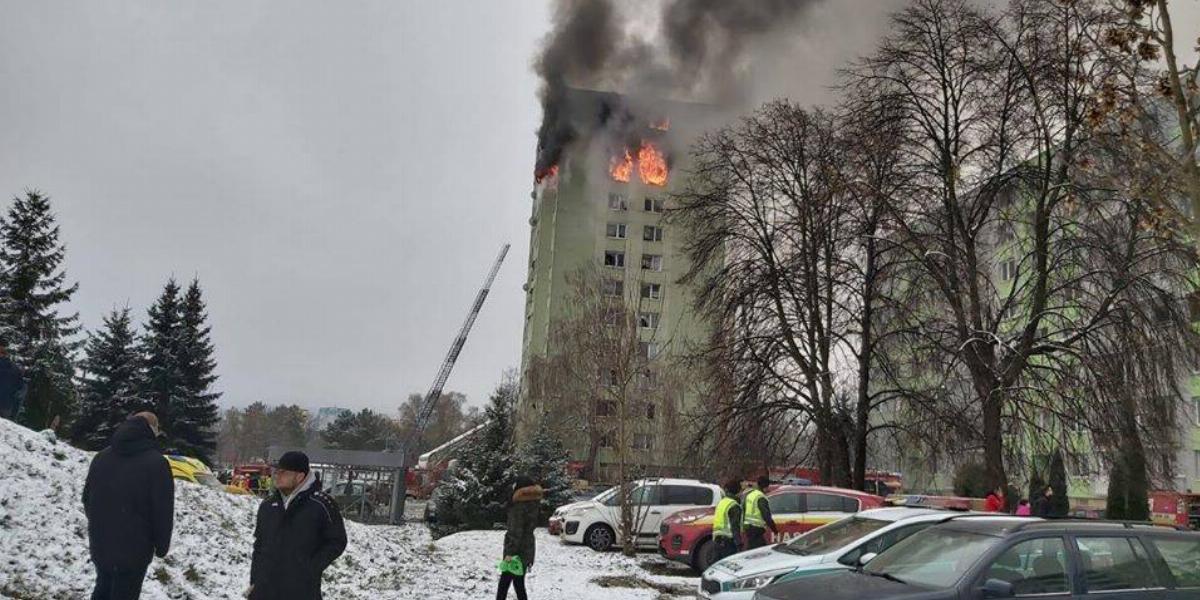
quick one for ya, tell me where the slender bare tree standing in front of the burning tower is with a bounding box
[527,266,684,554]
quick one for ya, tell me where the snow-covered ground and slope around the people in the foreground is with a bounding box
[0,420,696,600]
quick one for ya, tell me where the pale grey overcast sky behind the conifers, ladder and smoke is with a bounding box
[0,0,1200,410]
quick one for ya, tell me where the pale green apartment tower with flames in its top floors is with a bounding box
[517,89,713,481]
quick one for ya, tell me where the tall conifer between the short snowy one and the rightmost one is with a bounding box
[138,278,190,452]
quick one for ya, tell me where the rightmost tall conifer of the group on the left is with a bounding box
[170,280,221,462]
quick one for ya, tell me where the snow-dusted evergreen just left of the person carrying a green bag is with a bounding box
[432,382,517,536]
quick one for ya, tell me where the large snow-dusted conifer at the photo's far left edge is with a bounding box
[0,191,82,428]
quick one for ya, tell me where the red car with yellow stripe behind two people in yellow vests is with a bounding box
[659,485,883,572]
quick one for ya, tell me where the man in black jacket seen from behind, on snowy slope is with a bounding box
[83,413,175,600]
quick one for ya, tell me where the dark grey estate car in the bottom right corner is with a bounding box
[755,516,1200,600]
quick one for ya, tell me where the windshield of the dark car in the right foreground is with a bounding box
[864,527,1000,588]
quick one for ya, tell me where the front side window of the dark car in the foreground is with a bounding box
[984,538,1070,596]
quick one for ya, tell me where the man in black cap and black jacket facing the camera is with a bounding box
[247,451,346,600]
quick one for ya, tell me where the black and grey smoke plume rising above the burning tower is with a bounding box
[535,0,821,178]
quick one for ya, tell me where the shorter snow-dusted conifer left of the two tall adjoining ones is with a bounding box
[71,308,140,450]
